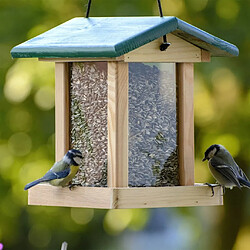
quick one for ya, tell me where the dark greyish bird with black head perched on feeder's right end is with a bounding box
[202,144,250,194]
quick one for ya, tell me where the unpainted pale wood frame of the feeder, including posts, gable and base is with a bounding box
[28,34,223,209]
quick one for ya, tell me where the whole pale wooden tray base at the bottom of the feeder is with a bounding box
[28,184,223,209]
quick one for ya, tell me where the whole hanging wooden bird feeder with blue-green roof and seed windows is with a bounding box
[11,17,238,209]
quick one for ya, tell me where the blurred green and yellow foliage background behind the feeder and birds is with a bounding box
[0,0,250,250]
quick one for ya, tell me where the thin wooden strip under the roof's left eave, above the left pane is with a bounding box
[38,56,124,62]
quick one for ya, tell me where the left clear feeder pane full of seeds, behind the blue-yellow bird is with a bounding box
[70,62,108,186]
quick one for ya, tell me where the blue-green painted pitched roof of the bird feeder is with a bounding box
[11,16,239,58]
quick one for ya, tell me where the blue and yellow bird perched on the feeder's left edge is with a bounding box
[24,149,83,190]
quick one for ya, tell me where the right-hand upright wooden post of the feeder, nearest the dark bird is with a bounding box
[176,63,194,186]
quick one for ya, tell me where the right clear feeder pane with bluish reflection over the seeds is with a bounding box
[129,63,179,187]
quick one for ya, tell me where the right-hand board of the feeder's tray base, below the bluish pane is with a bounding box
[113,186,223,208]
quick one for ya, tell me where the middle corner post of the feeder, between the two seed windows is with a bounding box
[108,62,128,187]
